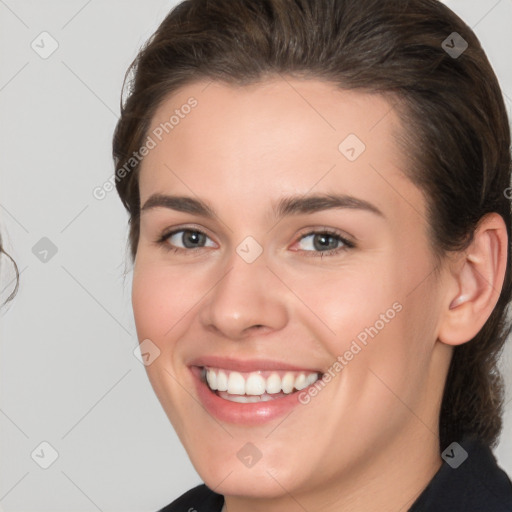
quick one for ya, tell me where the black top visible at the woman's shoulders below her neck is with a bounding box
[159,438,512,512]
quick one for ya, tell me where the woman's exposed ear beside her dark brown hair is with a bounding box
[438,213,508,345]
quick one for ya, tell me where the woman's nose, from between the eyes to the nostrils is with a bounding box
[199,249,288,340]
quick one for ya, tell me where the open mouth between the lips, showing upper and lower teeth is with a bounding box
[201,367,322,403]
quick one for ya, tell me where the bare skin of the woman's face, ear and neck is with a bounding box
[132,77,506,512]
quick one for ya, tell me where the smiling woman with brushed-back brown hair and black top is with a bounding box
[113,0,512,512]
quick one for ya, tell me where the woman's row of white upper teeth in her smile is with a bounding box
[206,368,318,395]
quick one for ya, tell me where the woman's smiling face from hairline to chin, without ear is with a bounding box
[132,78,450,497]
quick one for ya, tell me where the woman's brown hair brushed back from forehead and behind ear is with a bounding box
[113,0,512,448]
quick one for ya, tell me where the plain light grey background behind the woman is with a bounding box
[0,0,512,512]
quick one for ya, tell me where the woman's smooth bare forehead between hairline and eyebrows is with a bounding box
[136,78,422,223]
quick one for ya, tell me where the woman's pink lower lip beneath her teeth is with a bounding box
[191,366,307,425]
